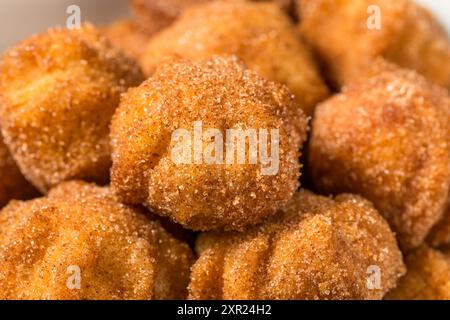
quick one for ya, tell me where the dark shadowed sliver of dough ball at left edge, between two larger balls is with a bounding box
[0,137,39,208]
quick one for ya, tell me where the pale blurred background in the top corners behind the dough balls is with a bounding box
[0,0,450,51]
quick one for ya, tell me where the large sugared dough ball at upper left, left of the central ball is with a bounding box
[0,25,143,192]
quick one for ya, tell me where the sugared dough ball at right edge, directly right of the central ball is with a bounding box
[308,63,450,249]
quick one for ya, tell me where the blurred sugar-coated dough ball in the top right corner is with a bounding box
[297,0,450,88]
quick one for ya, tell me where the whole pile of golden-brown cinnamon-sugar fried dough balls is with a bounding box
[0,0,450,300]
